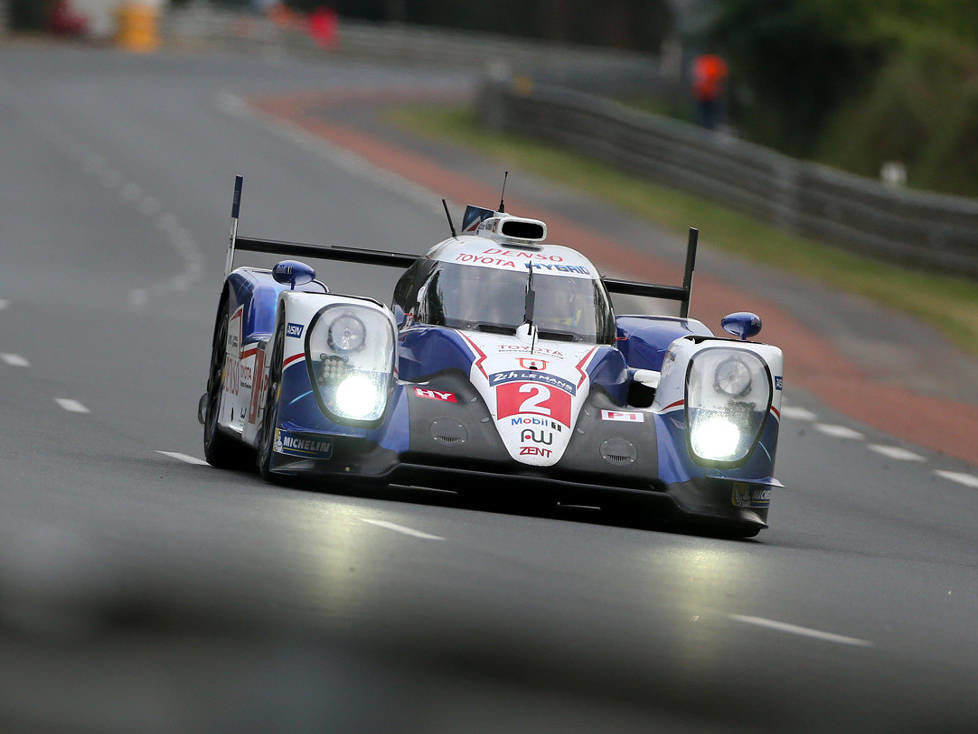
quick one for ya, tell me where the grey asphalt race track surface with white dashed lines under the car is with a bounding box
[0,44,978,732]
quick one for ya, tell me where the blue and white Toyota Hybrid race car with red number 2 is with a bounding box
[198,177,783,537]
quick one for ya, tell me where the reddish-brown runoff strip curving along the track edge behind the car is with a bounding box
[231,89,978,465]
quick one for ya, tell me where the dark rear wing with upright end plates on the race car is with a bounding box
[224,176,699,318]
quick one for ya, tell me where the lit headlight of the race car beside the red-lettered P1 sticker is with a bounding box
[686,347,772,463]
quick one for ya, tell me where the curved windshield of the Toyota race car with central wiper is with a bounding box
[418,263,615,343]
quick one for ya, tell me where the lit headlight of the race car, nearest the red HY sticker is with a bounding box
[306,304,394,421]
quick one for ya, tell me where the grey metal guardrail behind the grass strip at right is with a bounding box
[478,81,978,278]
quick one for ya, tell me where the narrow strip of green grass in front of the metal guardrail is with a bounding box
[388,105,978,354]
